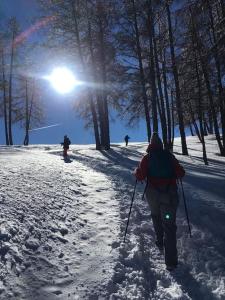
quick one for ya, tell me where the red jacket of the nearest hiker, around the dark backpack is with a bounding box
[134,145,185,187]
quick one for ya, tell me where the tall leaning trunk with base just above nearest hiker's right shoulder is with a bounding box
[166,2,188,155]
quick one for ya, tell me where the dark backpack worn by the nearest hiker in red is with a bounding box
[148,149,176,179]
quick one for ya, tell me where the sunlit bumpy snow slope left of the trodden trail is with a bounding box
[0,149,118,300]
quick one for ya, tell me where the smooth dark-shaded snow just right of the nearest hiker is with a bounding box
[179,162,225,248]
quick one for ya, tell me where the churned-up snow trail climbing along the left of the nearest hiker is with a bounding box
[70,145,191,299]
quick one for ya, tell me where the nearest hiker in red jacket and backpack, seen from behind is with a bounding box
[135,132,185,271]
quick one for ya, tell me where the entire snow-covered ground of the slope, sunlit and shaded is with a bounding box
[0,137,225,300]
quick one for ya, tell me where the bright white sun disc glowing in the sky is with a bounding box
[46,67,78,94]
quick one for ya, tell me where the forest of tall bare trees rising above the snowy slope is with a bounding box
[0,0,225,164]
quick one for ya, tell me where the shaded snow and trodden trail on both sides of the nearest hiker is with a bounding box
[69,144,225,300]
